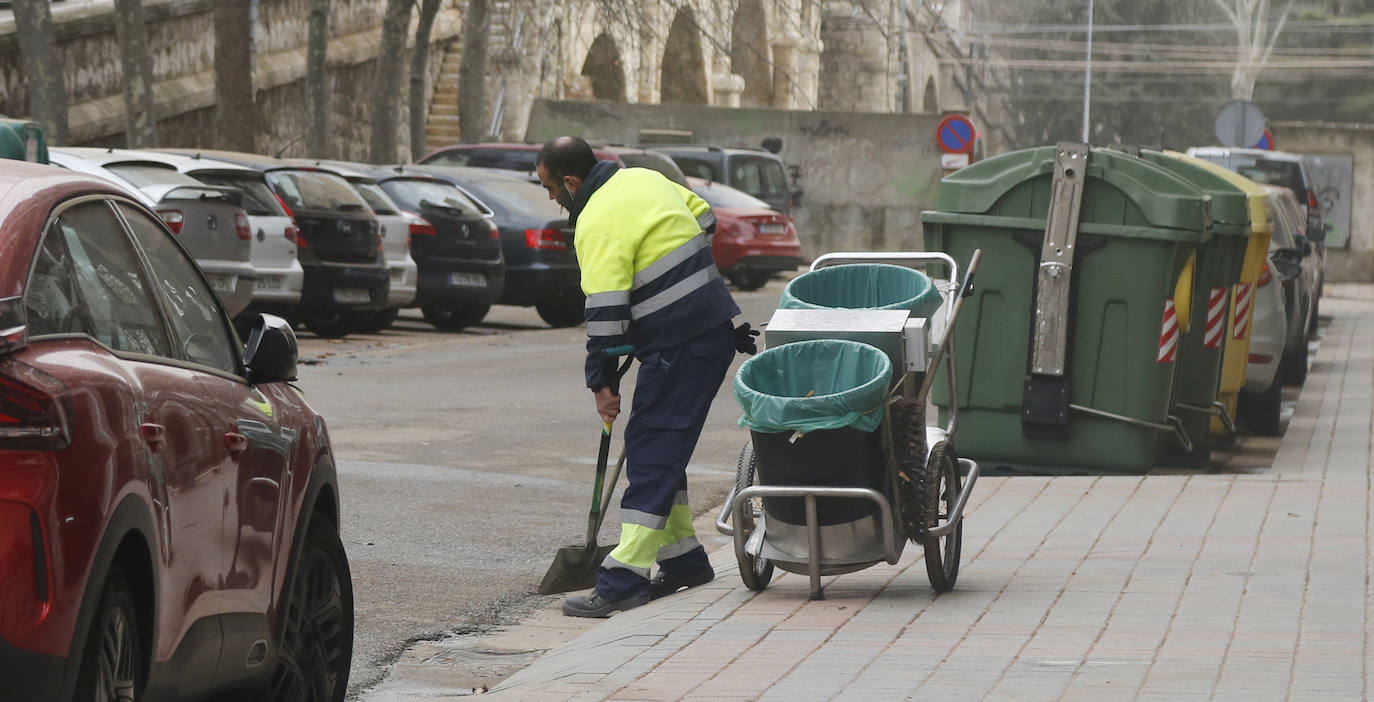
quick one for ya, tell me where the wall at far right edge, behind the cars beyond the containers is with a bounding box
[1274,122,1374,283]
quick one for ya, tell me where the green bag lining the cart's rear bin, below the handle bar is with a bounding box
[778,264,941,317]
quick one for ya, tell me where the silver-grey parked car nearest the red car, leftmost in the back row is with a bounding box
[48,148,257,316]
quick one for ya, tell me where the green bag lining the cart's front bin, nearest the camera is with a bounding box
[735,339,892,434]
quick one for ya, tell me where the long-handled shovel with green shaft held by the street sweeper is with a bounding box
[539,346,633,595]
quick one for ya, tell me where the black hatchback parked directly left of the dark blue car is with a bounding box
[309,163,507,331]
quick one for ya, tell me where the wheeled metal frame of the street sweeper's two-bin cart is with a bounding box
[716,251,982,600]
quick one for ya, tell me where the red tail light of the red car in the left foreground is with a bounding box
[0,359,71,451]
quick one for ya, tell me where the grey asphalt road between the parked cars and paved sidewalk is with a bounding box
[289,280,783,691]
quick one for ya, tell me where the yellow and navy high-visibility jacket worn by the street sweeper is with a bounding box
[573,161,739,389]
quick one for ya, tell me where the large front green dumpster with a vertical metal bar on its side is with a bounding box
[922,144,1212,473]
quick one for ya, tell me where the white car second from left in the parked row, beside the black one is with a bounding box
[139,151,305,327]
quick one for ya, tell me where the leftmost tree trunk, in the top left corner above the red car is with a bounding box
[14,0,67,144]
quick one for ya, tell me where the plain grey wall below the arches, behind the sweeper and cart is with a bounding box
[526,100,940,258]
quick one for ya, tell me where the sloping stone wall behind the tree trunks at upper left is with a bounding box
[0,0,462,159]
